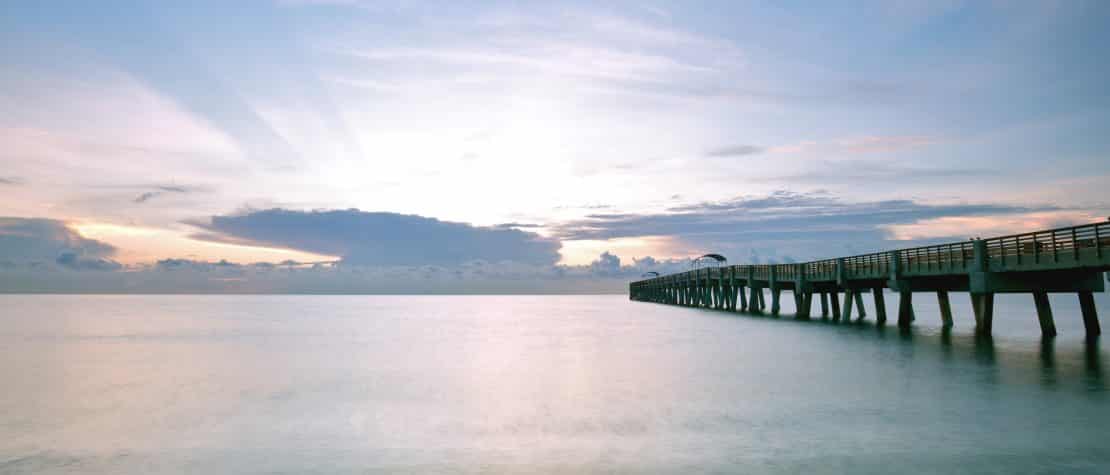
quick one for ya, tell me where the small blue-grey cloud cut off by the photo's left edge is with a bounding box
[0,218,119,270]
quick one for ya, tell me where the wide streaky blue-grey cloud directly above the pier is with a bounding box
[548,191,1061,262]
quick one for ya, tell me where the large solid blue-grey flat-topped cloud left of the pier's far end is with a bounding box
[190,209,559,265]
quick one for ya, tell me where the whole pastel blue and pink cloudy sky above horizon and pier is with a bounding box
[0,0,1110,293]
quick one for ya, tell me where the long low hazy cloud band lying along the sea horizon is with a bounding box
[0,248,690,294]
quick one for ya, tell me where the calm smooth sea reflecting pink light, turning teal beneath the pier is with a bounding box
[0,294,1110,474]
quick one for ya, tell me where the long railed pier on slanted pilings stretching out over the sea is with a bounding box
[628,222,1110,337]
